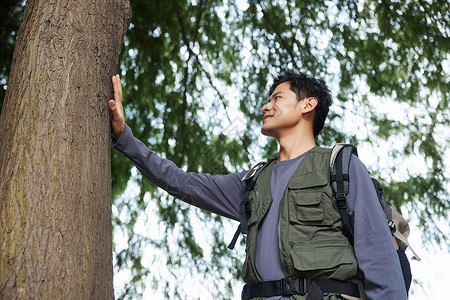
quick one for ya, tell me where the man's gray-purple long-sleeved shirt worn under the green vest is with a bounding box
[113,125,407,300]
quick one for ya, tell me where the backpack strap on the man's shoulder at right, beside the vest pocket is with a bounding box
[330,144,358,241]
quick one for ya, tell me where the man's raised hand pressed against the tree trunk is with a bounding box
[108,75,125,140]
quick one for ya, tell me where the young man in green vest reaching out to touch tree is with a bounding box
[109,73,407,300]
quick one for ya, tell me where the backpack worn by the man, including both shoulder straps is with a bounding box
[228,143,420,292]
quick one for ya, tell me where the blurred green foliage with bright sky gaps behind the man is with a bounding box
[0,0,450,299]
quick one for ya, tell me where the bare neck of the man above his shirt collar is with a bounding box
[278,133,316,161]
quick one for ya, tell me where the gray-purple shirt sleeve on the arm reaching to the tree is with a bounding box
[113,125,246,220]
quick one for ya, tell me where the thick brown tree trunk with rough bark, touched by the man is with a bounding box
[0,0,131,299]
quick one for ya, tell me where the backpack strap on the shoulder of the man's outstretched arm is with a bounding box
[228,158,276,250]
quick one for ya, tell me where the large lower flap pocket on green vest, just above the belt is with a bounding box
[291,238,357,280]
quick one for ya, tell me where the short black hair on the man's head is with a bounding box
[270,72,332,137]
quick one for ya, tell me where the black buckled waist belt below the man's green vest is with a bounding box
[241,278,361,300]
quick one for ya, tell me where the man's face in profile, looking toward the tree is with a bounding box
[261,82,303,139]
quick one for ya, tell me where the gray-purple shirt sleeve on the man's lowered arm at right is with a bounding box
[347,156,407,300]
